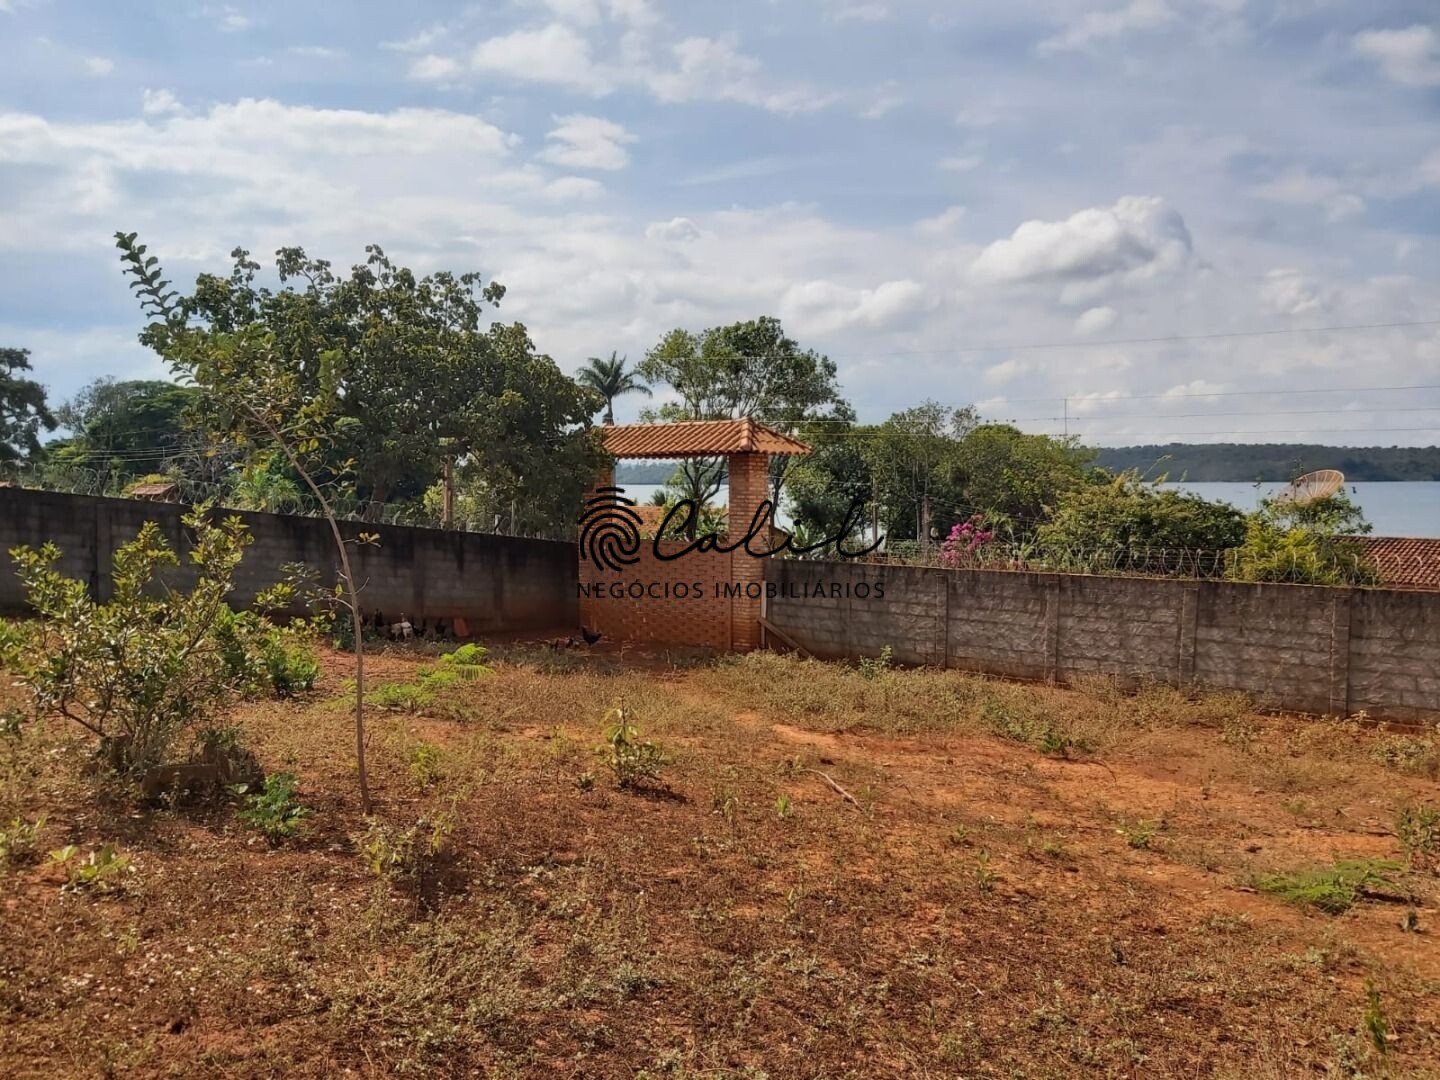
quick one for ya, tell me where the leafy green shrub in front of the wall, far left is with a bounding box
[0,507,280,778]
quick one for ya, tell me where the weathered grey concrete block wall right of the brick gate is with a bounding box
[766,559,1440,721]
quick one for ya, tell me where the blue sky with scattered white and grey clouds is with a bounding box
[0,0,1440,445]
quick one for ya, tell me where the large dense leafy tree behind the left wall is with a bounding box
[163,245,599,518]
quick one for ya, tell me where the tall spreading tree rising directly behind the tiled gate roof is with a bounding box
[636,315,844,529]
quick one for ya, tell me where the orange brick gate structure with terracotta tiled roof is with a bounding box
[580,419,809,651]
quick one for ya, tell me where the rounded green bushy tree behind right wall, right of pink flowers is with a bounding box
[1037,472,1246,567]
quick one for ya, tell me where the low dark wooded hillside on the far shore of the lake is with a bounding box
[1096,442,1440,484]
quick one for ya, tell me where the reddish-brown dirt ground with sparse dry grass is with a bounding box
[0,644,1440,1079]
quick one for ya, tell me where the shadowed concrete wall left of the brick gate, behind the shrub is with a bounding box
[0,488,579,632]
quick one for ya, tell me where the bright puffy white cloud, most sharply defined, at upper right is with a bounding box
[971,194,1191,302]
